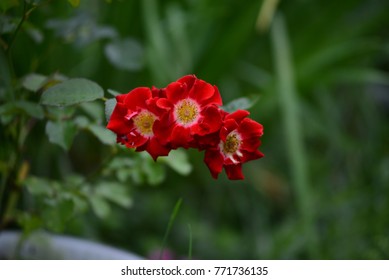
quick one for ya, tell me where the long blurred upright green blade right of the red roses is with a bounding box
[271,15,317,258]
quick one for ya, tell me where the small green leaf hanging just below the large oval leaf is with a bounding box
[46,121,77,150]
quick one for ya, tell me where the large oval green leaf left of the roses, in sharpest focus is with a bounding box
[40,78,104,106]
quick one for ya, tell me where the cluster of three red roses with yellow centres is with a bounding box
[107,75,263,180]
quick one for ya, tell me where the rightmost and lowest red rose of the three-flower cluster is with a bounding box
[204,110,263,180]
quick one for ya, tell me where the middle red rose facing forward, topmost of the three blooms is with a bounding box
[154,75,222,149]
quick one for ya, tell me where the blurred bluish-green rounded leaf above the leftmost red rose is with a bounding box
[104,38,144,71]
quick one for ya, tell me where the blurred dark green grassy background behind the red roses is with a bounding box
[0,0,389,259]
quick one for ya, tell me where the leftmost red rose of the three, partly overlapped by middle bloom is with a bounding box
[107,87,170,160]
